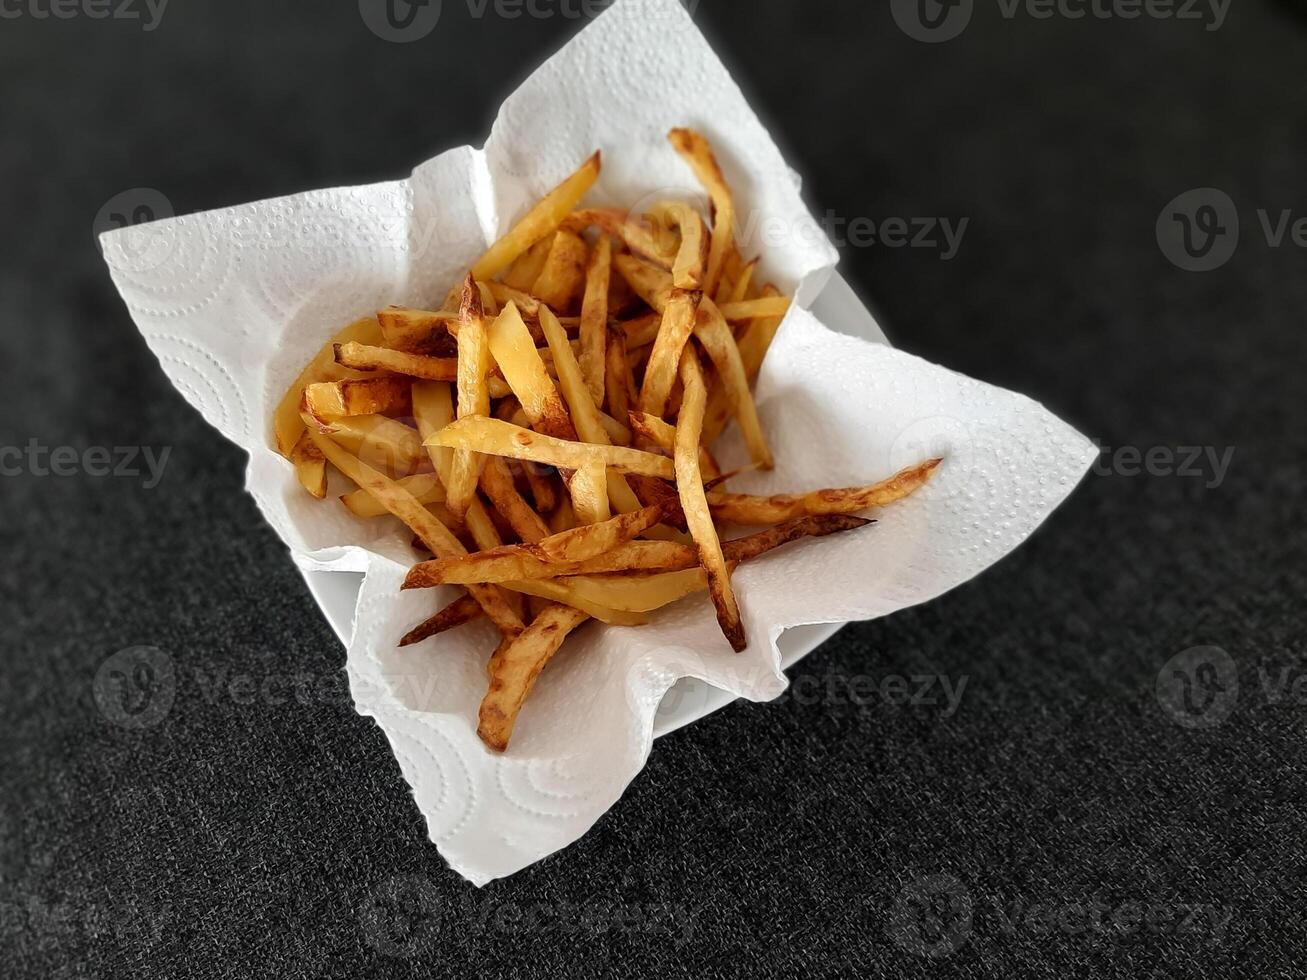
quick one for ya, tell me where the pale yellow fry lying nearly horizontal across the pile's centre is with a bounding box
[427,417,676,480]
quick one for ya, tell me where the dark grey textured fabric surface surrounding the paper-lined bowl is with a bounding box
[0,0,1307,977]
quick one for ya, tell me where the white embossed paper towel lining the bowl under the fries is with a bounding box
[102,0,1097,885]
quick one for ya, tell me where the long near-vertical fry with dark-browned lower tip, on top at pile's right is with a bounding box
[676,348,749,653]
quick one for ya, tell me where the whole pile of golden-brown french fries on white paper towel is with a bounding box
[274,129,940,751]
